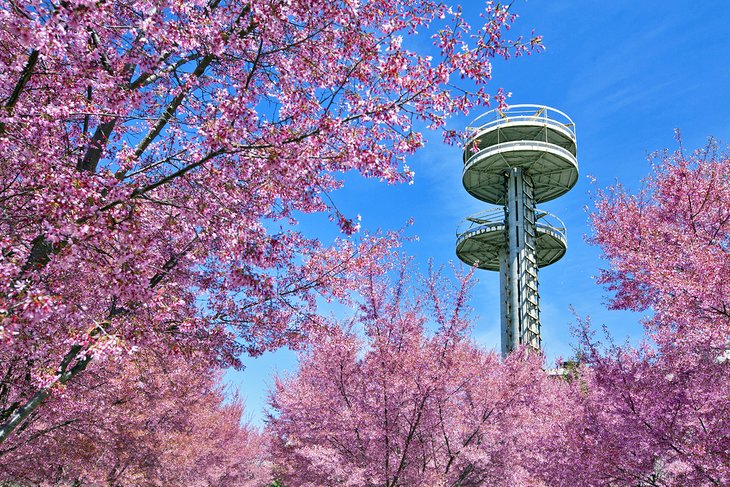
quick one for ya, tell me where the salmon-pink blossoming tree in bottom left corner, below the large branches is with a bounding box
[0,353,271,486]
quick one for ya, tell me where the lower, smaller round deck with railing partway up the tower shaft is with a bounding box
[456,209,568,271]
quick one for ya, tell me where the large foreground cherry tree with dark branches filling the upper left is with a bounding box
[0,0,540,443]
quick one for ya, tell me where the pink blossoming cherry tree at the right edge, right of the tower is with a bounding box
[546,140,730,485]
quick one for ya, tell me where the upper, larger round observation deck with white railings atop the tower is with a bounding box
[462,105,578,205]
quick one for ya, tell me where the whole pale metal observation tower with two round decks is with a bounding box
[456,105,578,355]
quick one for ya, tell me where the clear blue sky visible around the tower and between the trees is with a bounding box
[227,0,730,424]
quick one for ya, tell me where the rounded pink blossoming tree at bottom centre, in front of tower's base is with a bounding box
[269,264,571,486]
